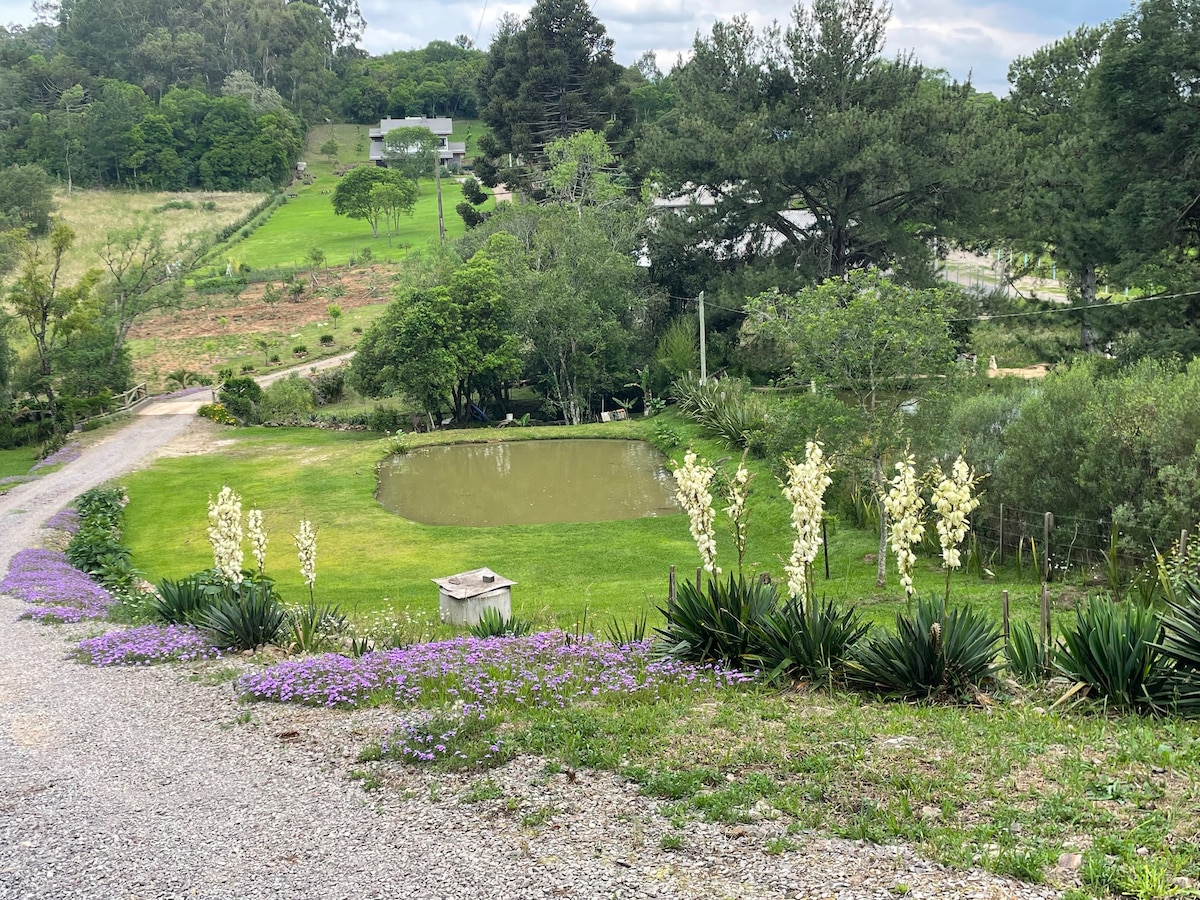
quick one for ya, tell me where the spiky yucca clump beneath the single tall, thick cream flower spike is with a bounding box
[749,598,870,682]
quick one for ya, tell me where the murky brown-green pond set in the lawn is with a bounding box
[378,440,679,526]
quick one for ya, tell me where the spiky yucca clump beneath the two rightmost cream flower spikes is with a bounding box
[846,596,1000,698]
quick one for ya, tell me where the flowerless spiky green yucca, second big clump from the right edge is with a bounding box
[1055,598,1170,707]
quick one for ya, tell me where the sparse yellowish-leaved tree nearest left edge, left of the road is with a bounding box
[8,223,100,410]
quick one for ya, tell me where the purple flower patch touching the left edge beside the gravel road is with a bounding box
[0,550,115,622]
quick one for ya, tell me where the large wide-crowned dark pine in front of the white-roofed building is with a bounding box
[638,0,1004,281]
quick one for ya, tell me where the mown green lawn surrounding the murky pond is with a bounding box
[125,418,1060,628]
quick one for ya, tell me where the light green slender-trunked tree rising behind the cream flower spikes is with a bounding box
[743,270,954,587]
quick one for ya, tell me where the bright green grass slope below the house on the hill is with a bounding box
[220,125,492,269]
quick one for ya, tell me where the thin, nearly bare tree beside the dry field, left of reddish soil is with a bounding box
[100,221,199,362]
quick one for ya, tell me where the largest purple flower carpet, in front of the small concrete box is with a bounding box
[238,631,751,710]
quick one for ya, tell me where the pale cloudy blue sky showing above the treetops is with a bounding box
[0,0,1130,95]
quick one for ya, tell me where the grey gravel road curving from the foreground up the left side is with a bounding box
[0,403,1058,900]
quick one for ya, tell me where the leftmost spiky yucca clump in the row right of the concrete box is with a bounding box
[655,574,779,668]
